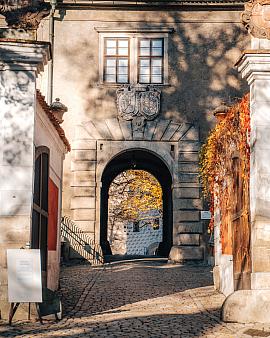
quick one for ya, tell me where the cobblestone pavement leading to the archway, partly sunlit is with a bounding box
[0,260,270,338]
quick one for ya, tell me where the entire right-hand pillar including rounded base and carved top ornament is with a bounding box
[223,0,270,323]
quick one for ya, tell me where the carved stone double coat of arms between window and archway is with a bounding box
[117,85,161,130]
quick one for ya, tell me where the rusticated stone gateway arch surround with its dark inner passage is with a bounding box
[71,109,204,261]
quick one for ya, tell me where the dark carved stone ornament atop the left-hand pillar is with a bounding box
[0,0,51,30]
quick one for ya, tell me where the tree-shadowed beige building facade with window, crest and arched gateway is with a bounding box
[34,1,249,261]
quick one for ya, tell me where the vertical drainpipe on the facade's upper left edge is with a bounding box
[47,0,57,105]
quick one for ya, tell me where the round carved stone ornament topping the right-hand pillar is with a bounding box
[241,0,270,39]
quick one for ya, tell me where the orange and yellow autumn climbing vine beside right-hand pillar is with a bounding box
[200,94,250,231]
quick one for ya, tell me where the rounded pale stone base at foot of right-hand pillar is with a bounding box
[221,290,270,323]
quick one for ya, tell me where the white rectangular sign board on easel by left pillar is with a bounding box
[7,249,42,303]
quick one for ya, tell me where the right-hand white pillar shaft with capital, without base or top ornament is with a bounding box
[238,50,270,289]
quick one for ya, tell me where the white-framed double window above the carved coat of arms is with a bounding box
[96,28,173,86]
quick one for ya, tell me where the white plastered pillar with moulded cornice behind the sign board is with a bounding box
[0,39,49,318]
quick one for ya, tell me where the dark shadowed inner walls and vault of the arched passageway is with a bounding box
[100,150,173,256]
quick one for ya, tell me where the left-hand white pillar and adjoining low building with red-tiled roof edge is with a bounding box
[0,38,70,319]
